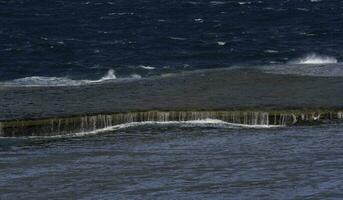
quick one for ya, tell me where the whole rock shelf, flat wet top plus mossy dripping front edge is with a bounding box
[0,69,343,136]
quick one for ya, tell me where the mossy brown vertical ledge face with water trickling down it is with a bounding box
[0,110,343,137]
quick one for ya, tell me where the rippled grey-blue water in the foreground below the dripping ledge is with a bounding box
[0,124,343,199]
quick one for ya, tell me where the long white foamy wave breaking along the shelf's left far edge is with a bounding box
[0,69,141,87]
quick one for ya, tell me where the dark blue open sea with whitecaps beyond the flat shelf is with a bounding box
[0,0,343,84]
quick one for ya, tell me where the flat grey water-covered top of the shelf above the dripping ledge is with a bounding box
[0,69,343,121]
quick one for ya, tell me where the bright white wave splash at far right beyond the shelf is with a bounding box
[291,53,338,64]
